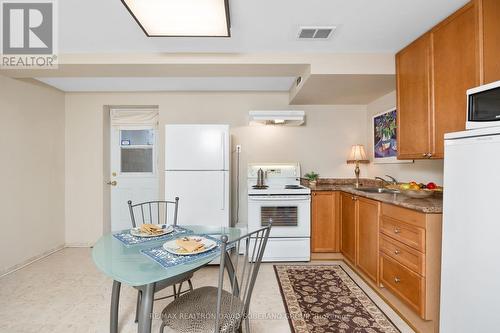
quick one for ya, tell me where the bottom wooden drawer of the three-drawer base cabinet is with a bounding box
[380,254,425,317]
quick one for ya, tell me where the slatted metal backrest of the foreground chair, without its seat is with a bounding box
[215,220,272,332]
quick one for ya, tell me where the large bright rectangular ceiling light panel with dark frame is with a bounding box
[122,0,231,37]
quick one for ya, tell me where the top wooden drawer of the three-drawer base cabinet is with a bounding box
[380,216,425,252]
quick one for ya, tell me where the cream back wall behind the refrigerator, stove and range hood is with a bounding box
[66,92,367,245]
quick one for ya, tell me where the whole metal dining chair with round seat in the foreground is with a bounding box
[160,222,272,333]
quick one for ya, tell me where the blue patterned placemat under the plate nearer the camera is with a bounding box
[141,235,226,268]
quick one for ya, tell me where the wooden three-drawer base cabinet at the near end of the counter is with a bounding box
[379,204,442,320]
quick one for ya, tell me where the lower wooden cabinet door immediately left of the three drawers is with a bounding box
[356,197,380,282]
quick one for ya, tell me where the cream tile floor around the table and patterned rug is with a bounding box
[0,248,412,333]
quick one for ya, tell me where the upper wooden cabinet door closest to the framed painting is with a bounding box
[396,33,432,159]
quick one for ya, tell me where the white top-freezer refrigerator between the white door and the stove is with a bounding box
[165,125,230,227]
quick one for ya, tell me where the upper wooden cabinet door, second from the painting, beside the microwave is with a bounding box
[429,2,478,158]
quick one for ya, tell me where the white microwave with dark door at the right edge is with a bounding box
[465,81,500,130]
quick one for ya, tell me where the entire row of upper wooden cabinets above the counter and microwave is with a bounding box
[396,0,500,159]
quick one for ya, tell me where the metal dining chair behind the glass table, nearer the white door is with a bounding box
[127,197,193,323]
